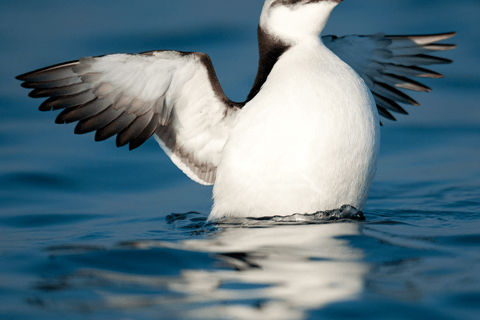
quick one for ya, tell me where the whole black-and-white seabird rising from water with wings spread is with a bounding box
[17,0,455,219]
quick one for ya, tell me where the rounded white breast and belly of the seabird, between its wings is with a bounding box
[211,39,380,218]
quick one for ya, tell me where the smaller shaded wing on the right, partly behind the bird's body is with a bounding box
[322,32,456,120]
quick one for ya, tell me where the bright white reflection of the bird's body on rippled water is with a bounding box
[166,223,368,319]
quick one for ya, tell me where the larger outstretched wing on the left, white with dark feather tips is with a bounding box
[17,51,242,184]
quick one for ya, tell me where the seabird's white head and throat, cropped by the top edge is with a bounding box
[260,0,342,41]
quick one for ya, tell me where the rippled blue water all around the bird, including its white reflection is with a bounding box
[0,0,480,319]
